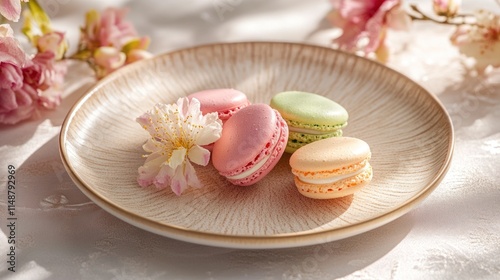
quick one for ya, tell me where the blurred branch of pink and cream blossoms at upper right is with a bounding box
[327,0,500,69]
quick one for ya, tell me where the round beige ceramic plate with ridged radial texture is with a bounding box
[60,42,453,248]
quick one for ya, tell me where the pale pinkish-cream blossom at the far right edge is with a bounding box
[451,11,500,70]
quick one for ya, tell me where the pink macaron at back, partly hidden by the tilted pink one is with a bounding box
[188,88,250,122]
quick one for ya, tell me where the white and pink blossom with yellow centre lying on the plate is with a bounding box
[137,97,222,195]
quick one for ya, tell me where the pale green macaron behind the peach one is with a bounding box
[270,91,349,153]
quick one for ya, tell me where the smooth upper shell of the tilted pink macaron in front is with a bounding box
[212,104,277,177]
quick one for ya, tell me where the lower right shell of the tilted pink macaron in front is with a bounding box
[229,111,288,186]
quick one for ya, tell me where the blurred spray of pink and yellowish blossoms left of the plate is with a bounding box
[0,0,152,124]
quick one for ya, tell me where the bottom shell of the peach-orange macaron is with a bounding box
[295,164,373,199]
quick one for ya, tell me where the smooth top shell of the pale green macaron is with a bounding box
[271,91,348,128]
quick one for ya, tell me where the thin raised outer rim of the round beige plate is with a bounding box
[59,41,455,249]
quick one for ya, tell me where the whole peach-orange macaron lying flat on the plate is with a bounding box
[290,137,373,199]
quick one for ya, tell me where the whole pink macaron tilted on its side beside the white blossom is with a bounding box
[212,104,288,186]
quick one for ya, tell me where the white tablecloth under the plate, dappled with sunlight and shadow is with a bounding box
[0,0,500,279]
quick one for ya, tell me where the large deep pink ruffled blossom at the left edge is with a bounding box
[0,24,66,124]
